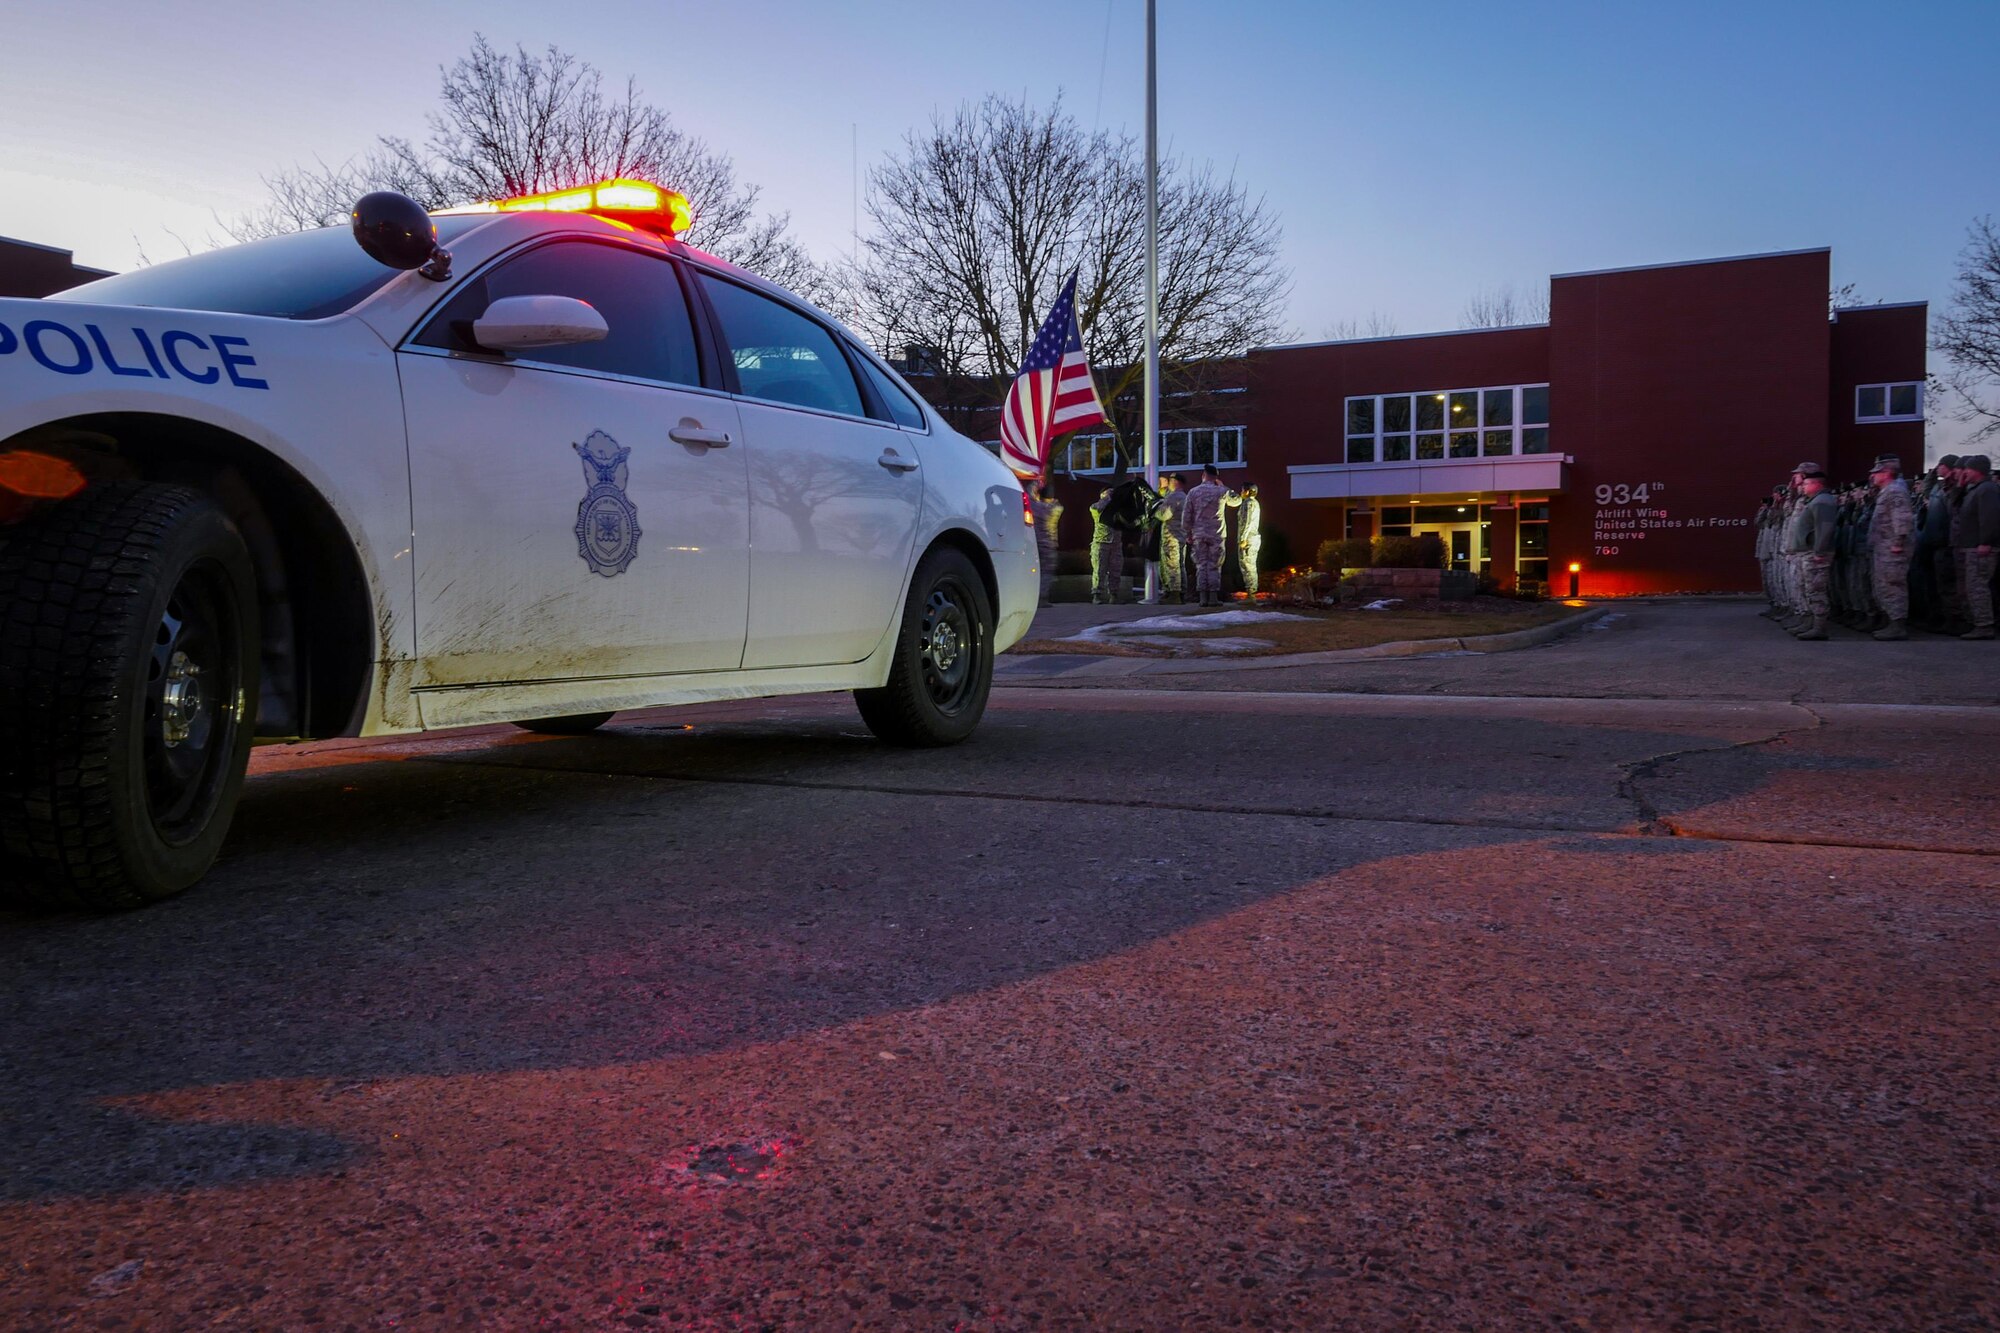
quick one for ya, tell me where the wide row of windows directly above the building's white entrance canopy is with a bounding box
[1344,384,1548,462]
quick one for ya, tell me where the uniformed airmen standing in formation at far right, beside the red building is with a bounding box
[1756,454,2000,642]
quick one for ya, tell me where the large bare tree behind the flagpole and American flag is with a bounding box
[846,96,1290,446]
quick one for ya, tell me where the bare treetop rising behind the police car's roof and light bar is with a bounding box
[240,36,822,286]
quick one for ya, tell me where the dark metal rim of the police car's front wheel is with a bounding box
[142,564,242,843]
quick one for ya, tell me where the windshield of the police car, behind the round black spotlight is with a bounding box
[48,214,490,320]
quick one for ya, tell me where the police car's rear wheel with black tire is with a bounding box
[854,546,994,747]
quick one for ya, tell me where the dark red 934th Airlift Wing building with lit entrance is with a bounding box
[1008,250,1926,594]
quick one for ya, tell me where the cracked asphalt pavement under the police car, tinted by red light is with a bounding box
[0,600,2000,1329]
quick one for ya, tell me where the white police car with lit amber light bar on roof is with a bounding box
[0,180,1036,907]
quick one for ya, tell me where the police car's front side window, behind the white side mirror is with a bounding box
[416,240,702,384]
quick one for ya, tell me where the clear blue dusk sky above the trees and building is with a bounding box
[0,0,2000,446]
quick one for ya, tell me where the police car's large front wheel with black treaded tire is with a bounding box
[0,482,258,911]
